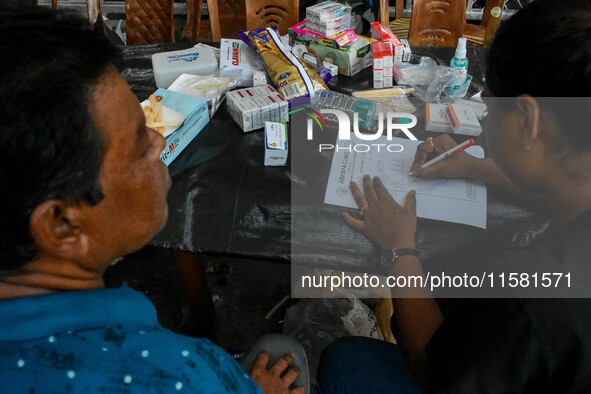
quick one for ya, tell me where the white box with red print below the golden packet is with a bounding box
[226,85,289,132]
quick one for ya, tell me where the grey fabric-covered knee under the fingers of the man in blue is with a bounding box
[242,334,310,394]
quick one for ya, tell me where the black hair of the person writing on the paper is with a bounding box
[486,0,591,153]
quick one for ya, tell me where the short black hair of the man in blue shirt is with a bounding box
[0,1,120,276]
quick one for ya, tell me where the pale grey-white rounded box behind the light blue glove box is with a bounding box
[152,46,218,88]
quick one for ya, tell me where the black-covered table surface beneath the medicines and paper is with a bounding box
[121,43,545,272]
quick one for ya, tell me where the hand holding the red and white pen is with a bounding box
[410,134,481,178]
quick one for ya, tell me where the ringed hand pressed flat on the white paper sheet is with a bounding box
[343,175,417,249]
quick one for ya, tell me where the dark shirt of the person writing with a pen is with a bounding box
[427,212,591,393]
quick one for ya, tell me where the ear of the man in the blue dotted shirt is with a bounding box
[29,200,89,259]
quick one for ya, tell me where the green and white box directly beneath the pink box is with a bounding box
[310,36,373,76]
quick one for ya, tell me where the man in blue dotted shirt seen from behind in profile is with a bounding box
[0,3,304,393]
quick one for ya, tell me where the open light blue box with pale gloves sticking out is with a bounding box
[148,89,209,165]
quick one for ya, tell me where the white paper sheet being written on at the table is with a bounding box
[324,135,486,228]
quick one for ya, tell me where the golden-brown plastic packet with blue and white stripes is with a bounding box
[239,28,328,100]
